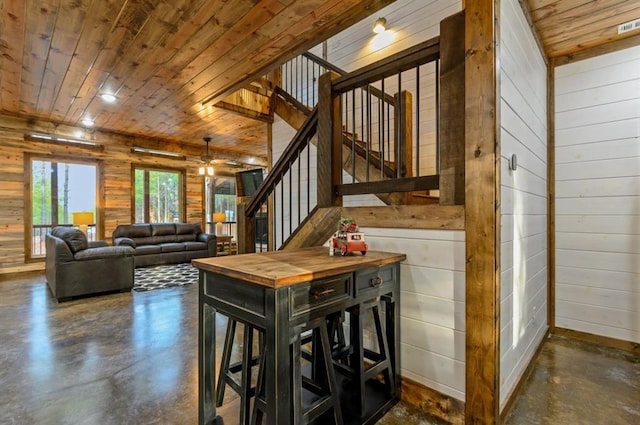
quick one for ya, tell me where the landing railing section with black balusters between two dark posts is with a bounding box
[331,37,440,195]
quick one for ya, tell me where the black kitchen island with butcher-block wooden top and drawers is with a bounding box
[193,247,406,425]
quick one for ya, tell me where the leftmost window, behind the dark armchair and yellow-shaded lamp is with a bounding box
[27,158,98,259]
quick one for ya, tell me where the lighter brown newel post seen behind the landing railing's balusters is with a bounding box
[394,90,419,177]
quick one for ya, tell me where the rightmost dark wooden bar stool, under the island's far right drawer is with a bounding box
[344,296,396,417]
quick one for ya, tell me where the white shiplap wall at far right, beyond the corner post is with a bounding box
[555,46,640,343]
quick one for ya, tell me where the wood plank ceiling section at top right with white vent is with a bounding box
[527,0,640,58]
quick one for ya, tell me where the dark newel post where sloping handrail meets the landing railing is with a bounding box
[318,72,342,207]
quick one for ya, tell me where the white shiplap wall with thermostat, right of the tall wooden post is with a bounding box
[500,0,547,409]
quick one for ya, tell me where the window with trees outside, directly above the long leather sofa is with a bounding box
[134,167,184,223]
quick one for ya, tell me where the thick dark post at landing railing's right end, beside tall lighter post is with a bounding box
[438,11,464,205]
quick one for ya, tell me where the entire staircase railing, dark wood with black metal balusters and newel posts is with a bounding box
[238,38,440,252]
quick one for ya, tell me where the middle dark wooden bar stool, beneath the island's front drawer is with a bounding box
[251,317,343,425]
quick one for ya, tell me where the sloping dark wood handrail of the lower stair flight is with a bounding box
[245,106,318,217]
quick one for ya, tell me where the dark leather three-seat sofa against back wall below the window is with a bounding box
[112,223,216,267]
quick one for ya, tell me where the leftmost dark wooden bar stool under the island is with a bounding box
[216,318,264,425]
